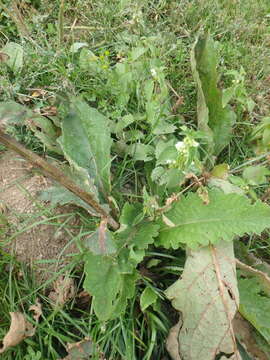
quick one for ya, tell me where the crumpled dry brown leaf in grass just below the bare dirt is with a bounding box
[48,276,75,307]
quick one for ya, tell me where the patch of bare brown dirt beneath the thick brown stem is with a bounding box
[0,151,78,279]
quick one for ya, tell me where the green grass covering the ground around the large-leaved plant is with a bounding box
[0,0,270,360]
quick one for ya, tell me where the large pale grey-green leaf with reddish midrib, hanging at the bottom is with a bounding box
[166,240,241,360]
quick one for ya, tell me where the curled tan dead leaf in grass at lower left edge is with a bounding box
[0,312,35,354]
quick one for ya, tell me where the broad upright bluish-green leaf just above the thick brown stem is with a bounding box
[60,97,112,193]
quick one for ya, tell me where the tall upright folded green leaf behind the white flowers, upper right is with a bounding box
[191,35,236,155]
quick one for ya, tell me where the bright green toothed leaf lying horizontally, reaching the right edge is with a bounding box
[158,190,270,249]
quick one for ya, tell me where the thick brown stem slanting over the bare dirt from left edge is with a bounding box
[0,129,119,230]
